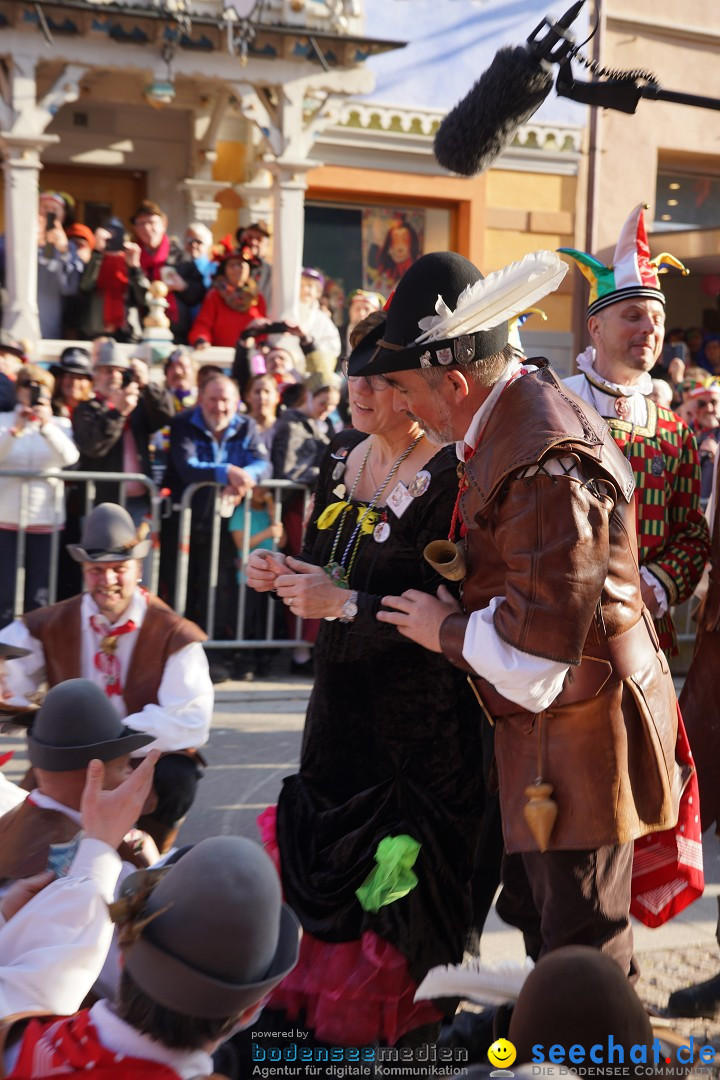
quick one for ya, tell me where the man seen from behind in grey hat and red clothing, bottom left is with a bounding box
[0,836,301,1080]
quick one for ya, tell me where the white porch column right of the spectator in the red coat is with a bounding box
[268,161,315,322]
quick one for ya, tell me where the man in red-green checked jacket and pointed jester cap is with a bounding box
[560,204,710,656]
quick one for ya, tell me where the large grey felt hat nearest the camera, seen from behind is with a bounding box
[121,836,302,1020]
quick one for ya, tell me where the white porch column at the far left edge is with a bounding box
[0,132,57,345]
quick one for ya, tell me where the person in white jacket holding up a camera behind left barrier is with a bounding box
[0,364,79,626]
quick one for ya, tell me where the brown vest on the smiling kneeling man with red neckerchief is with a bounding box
[23,595,207,715]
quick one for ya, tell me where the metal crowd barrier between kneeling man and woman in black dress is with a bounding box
[173,480,310,649]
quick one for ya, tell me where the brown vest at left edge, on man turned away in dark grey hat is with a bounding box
[0,799,80,880]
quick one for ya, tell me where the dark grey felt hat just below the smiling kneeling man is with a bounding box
[27,678,153,772]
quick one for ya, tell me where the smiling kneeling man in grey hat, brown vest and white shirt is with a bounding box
[2,502,213,850]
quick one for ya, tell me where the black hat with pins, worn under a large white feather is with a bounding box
[348,252,508,376]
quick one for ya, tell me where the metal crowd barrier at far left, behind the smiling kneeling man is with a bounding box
[0,469,161,618]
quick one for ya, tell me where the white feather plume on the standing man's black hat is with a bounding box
[416,251,568,345]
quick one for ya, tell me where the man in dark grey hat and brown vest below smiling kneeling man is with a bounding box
[0,678,152,883]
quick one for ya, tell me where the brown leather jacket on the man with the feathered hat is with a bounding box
[440,360,679,851]
